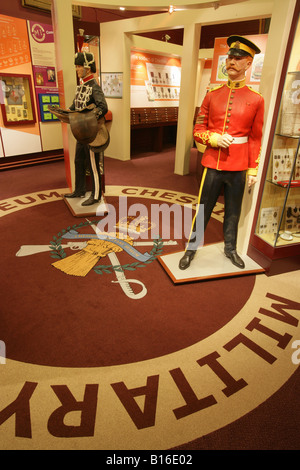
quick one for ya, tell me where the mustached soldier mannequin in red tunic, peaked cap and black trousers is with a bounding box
[179,36,264,269]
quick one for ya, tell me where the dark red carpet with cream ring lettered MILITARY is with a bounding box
[0,149,300,452]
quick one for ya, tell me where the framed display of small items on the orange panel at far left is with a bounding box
[0,73,36,126]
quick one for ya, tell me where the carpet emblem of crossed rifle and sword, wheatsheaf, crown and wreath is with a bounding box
[16,216,177,300]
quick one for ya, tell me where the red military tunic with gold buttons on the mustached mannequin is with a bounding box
[194,80,264,176]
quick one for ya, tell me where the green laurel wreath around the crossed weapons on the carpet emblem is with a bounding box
[49,220,164,274]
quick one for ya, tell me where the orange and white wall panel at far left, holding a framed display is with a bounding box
[0,15,42,158]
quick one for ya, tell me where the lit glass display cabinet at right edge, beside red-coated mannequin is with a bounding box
[252,10,300,259]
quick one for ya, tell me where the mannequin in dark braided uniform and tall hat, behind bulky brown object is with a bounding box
[65,52,108,206]
